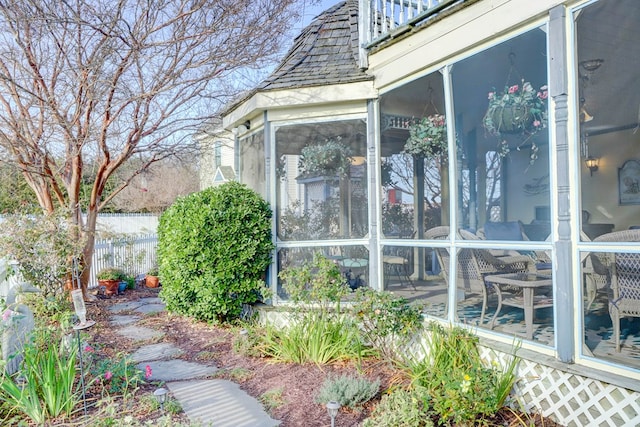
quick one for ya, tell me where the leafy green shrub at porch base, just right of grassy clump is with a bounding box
[352,288,423,360]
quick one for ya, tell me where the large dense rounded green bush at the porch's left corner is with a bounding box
[158,182,274,321]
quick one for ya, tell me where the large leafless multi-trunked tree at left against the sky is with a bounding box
[0,0,302,298]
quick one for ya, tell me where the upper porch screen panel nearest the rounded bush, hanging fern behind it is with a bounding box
[275,120,368,241]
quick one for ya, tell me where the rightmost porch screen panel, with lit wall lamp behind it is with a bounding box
[574,0,640,369]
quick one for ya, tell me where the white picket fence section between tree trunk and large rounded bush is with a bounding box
[89,234,158,288]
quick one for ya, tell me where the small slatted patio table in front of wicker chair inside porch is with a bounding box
[485,273,553,340]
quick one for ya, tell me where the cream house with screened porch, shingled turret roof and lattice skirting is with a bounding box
[222,0,640,425]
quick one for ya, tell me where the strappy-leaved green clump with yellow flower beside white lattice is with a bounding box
[403,322,519,425]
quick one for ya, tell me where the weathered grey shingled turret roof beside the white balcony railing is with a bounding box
[257,0,373,91]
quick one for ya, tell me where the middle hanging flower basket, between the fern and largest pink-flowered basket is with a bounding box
[402,114,448,159]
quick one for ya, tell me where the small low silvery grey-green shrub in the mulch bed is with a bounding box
[316,375,380,409]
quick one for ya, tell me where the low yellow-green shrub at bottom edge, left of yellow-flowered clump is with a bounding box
[362,388,433,427]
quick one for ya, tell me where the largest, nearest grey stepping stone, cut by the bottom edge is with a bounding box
[166,380,280,427]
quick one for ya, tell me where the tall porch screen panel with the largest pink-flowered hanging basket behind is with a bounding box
[449,28,555,346]
